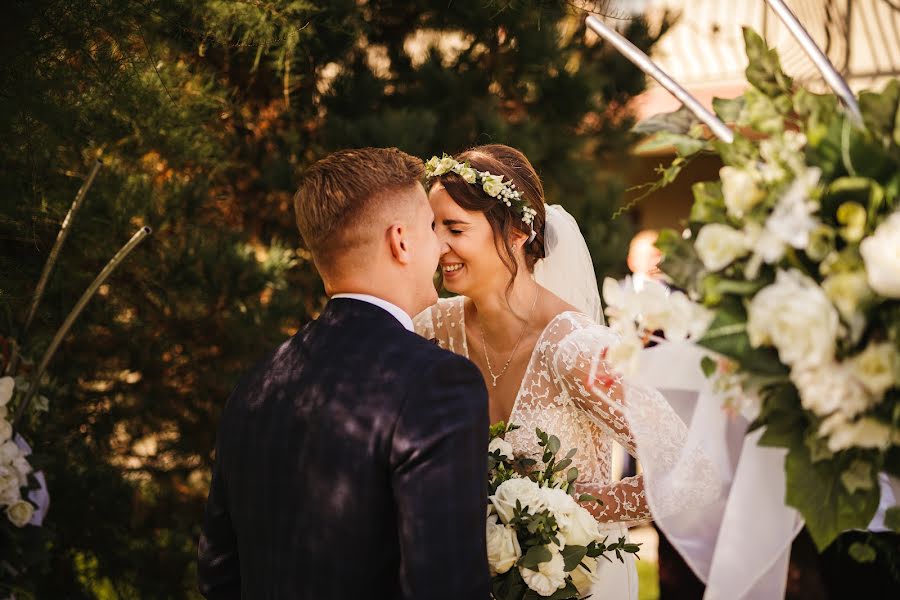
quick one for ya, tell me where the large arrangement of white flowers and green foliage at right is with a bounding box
[604,29,900,550]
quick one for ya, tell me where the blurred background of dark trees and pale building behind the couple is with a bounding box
[0,0,900,598]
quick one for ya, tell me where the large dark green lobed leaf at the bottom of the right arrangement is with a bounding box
[785,444,879,551]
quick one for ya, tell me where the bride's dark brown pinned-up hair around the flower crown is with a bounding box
[431,144,545,278]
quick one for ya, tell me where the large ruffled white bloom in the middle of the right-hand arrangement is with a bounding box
[747,270,839,366]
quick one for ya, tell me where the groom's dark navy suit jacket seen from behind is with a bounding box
[199,299,489,600]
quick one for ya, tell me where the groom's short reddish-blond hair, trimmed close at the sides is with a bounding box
[294,148,425,270]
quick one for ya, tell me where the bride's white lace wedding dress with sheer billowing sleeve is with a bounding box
[415,296,719,600]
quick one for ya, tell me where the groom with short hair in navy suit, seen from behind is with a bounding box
[199,148,489,600]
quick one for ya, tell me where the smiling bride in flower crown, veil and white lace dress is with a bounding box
[415,144,715,599]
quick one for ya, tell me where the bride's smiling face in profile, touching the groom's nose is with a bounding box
[428,184,512,297]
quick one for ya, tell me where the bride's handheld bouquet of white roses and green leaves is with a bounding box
[487,422,639,600]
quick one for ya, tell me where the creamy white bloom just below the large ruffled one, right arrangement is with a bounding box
[791,362,872,417]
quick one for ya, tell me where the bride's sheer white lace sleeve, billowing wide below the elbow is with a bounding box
[554,324,722,521]
